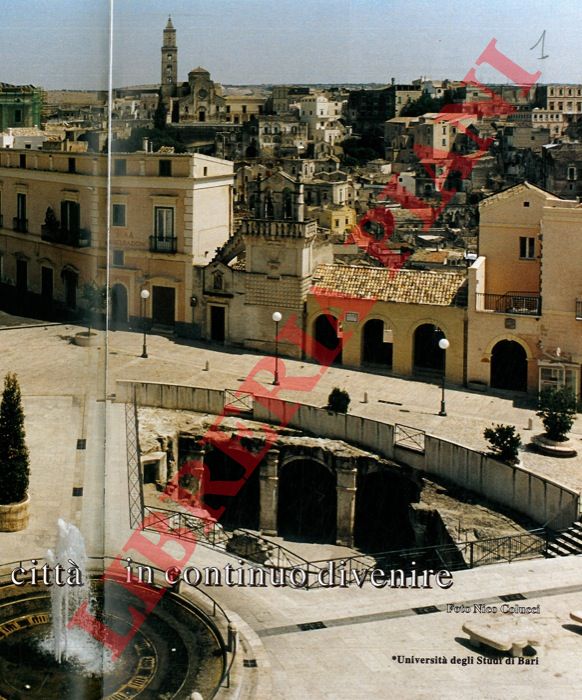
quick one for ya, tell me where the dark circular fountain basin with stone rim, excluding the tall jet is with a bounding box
[0,577,226,700]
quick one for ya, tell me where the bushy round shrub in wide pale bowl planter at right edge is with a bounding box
[532,386,576,457]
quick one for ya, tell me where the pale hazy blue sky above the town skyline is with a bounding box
[0,0,582,89]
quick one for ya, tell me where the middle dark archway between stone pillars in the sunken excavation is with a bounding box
[277,455,337,544]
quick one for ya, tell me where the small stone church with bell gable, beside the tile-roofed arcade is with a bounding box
[193,180,333,357]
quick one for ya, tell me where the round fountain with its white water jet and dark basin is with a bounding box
[0,520,225,700]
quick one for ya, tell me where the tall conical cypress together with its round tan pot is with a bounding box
[0,374,29,532]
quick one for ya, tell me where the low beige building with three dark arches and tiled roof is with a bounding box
[305,264,466,384]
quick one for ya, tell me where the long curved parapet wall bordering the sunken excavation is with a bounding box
[116,381,580,529]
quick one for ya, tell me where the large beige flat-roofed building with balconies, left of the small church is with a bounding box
[0,150,233,335]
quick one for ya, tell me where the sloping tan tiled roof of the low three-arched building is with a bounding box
[310,265,466,306]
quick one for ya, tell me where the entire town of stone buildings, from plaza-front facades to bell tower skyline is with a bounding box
[0,18,582,395]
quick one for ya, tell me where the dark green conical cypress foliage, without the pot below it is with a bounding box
[0,373,29,505]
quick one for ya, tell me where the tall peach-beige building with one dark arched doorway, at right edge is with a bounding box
[467,183,582,396]
